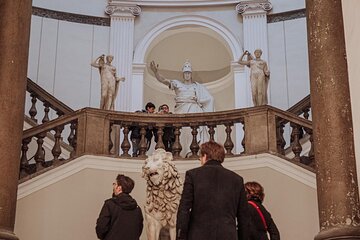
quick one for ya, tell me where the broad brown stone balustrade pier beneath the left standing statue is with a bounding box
[76,110,110,156]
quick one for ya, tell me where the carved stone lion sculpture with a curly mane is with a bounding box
[142,148,182,240]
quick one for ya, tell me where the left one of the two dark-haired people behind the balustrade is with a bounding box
[129,102,156,157]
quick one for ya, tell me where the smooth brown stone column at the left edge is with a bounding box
[0,0,32,240]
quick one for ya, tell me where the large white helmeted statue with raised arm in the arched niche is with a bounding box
[150,61,214,156]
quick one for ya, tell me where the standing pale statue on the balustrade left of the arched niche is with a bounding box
[91,54,125,110]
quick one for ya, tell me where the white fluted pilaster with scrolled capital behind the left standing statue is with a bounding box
[105,0,141,111]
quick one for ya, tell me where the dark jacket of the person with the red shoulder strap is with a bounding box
[249,197,280,240]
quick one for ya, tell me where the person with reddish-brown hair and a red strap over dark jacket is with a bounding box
[245,182,280,240]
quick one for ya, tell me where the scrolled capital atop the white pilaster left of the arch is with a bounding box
[105,0,141,17]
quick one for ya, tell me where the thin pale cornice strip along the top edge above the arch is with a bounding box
[109,0,240,7]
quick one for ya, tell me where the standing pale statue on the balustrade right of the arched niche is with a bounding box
[239,49,270,106]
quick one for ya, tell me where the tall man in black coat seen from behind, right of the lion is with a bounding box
[176,141,249,240]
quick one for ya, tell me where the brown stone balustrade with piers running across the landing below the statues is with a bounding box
[20,106,313,178]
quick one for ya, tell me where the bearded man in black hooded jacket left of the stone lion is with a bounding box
[95,174,143,240]
